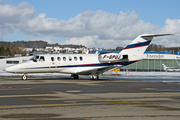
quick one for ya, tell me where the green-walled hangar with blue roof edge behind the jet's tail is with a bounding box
[92,51,180,72]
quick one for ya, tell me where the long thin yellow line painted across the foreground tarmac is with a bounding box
[0,101,158,108]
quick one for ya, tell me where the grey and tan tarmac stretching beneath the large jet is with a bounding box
[0,75,180,120]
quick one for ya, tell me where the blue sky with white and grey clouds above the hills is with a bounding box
[0,0,180,48]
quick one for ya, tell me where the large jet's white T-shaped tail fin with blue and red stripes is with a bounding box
[120,34,172,60]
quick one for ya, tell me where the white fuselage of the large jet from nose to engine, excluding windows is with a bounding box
[6,54,117,74]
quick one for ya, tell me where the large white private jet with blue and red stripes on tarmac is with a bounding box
[6,34,171,80]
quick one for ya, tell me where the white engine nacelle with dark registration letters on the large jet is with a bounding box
[99,53,128,62]
